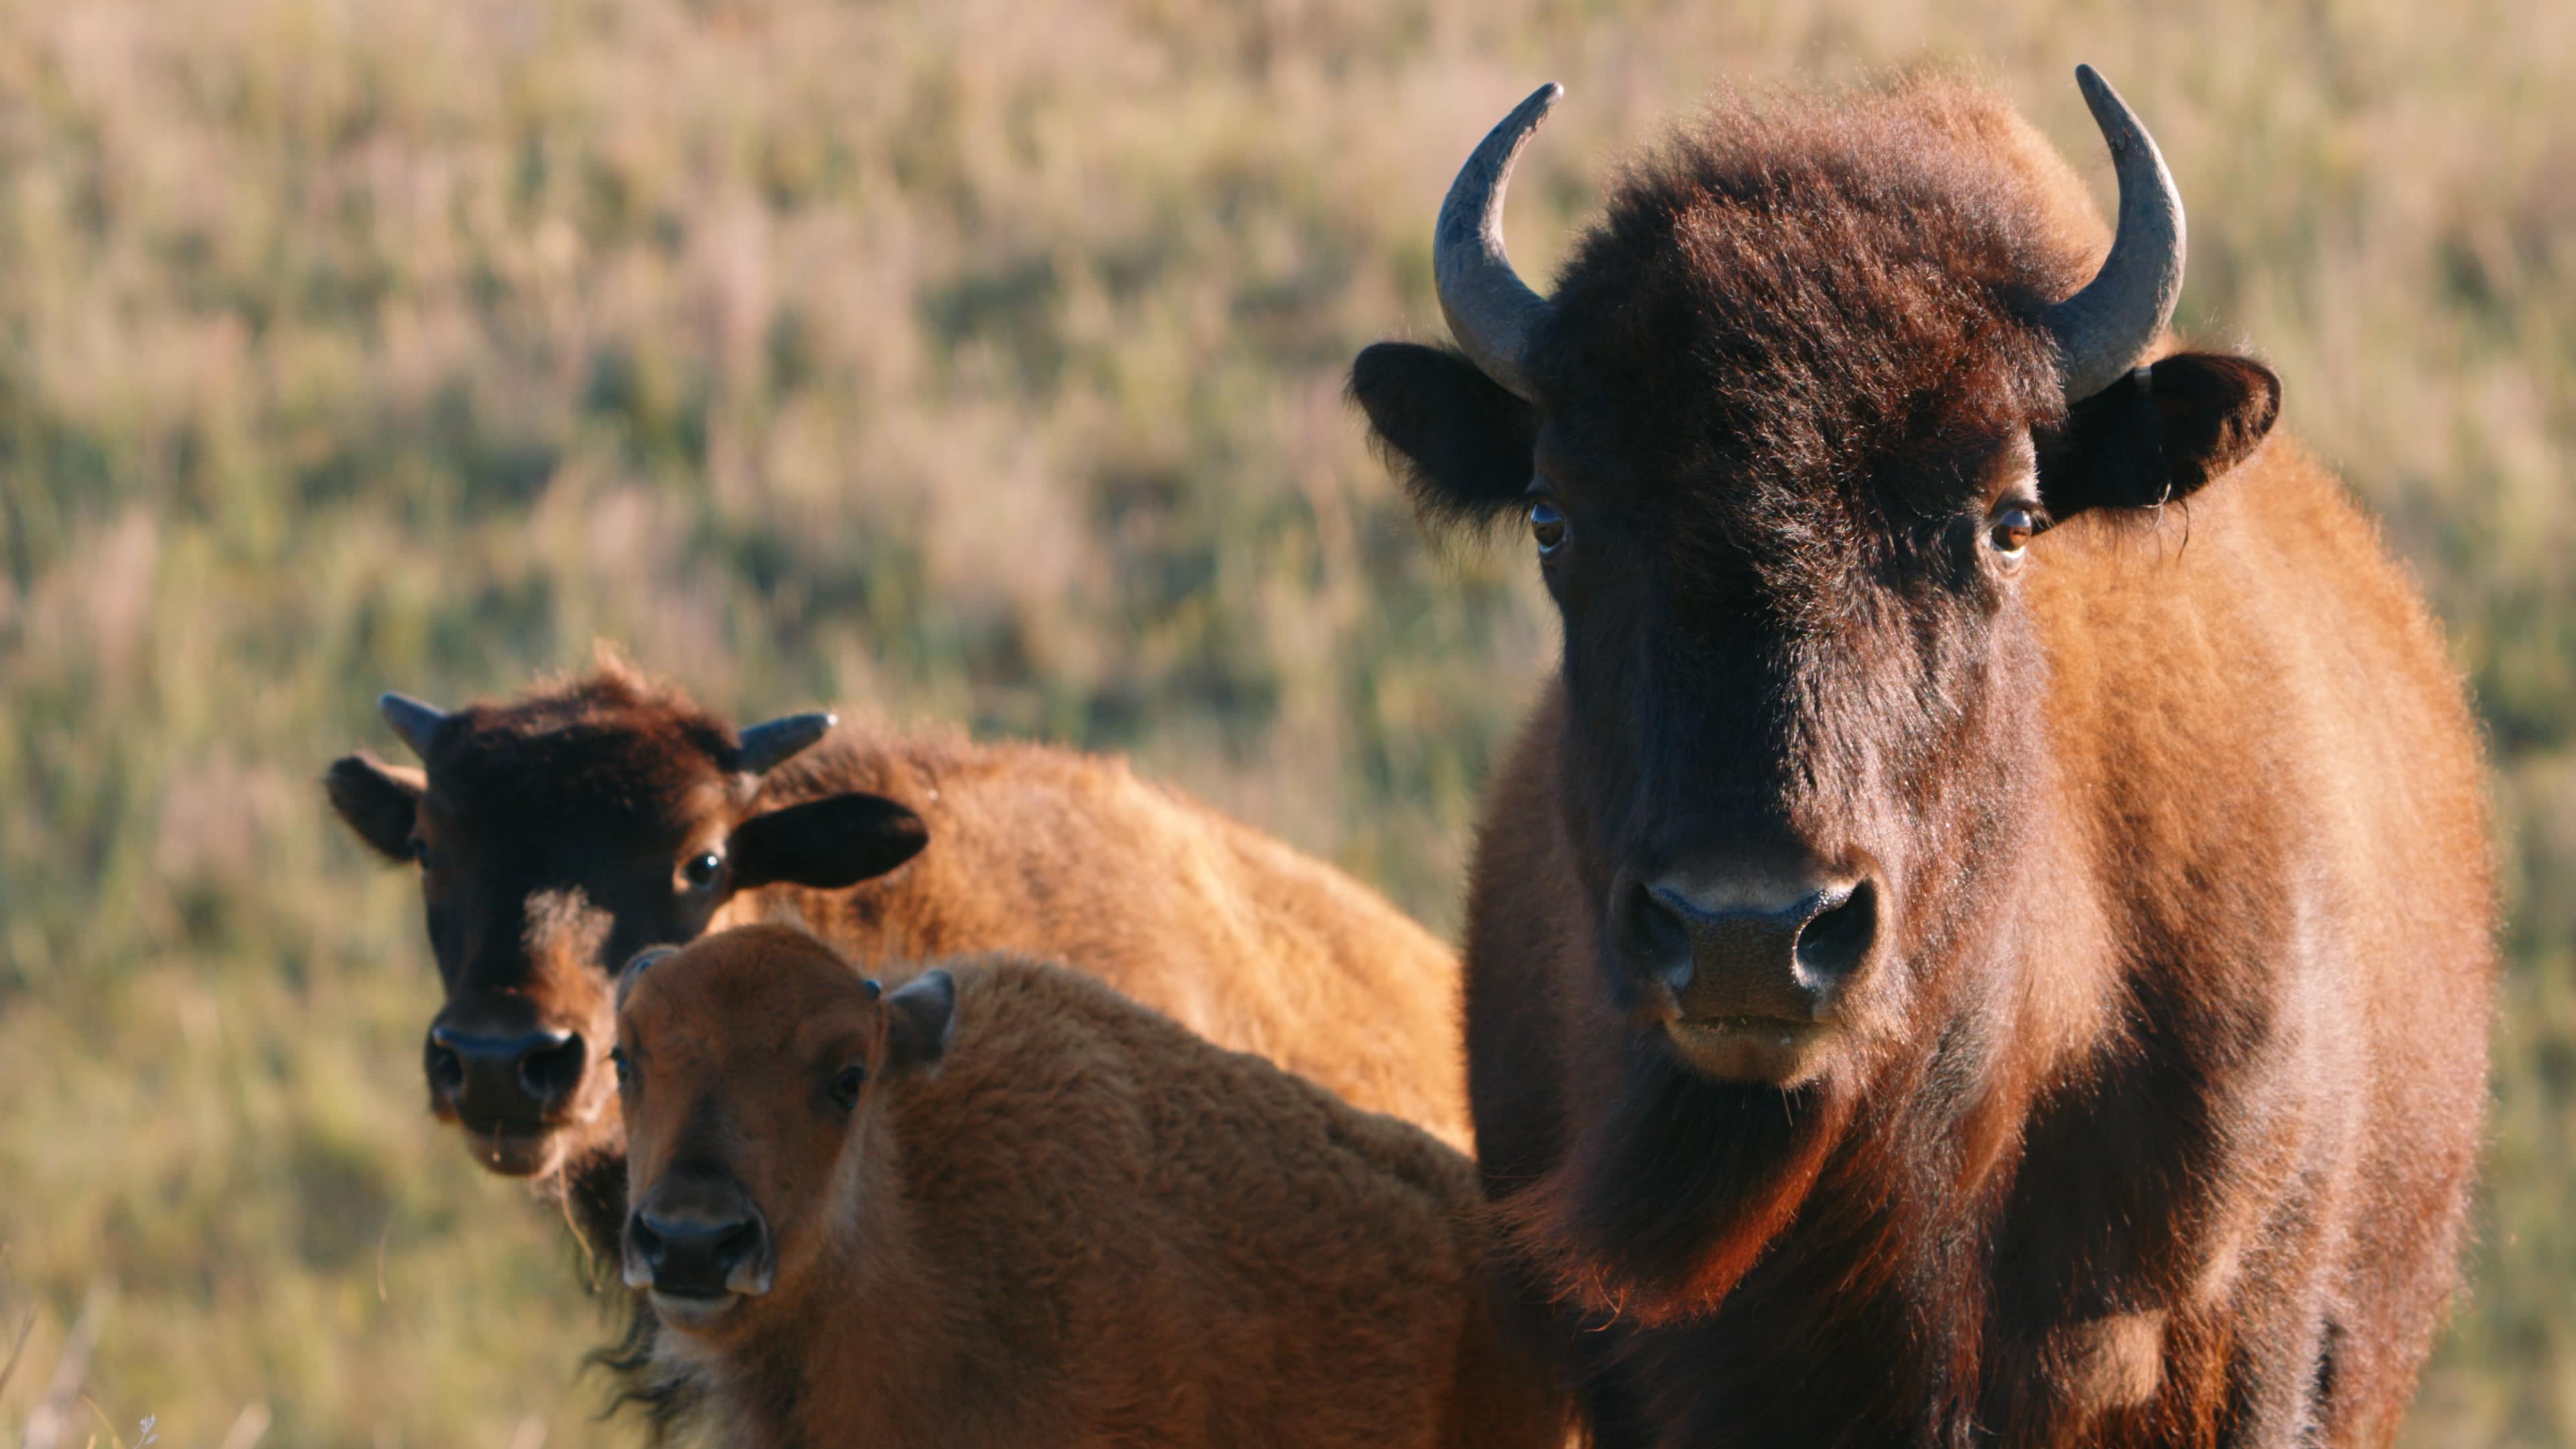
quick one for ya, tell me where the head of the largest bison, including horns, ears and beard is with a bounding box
[1352,70,2277,1315]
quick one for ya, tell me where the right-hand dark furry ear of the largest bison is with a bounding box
[2040,354,2279,519]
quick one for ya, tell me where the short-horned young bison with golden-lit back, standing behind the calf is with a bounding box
[325,660,1466,1248]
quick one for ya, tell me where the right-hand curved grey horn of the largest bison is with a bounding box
[2045,64,2182,402]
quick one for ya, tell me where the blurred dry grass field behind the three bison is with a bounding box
[0,0,2576,1449]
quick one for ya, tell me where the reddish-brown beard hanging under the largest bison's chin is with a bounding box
[1499,1049,1852,1326]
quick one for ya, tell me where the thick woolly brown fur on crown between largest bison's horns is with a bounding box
[1536,80,2110,559]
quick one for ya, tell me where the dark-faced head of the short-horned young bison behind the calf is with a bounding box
[325,667,925,1176]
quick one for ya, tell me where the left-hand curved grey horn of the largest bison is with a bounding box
[1432,80,1566,400]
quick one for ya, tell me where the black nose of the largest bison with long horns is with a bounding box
[1620,871,1878,1021]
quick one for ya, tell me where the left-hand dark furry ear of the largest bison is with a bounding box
[1350,343,1538,523]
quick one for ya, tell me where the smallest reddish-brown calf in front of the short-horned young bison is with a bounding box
[619,926,1564,1449]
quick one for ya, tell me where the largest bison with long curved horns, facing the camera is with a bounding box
[1352,70,2493,1446]
